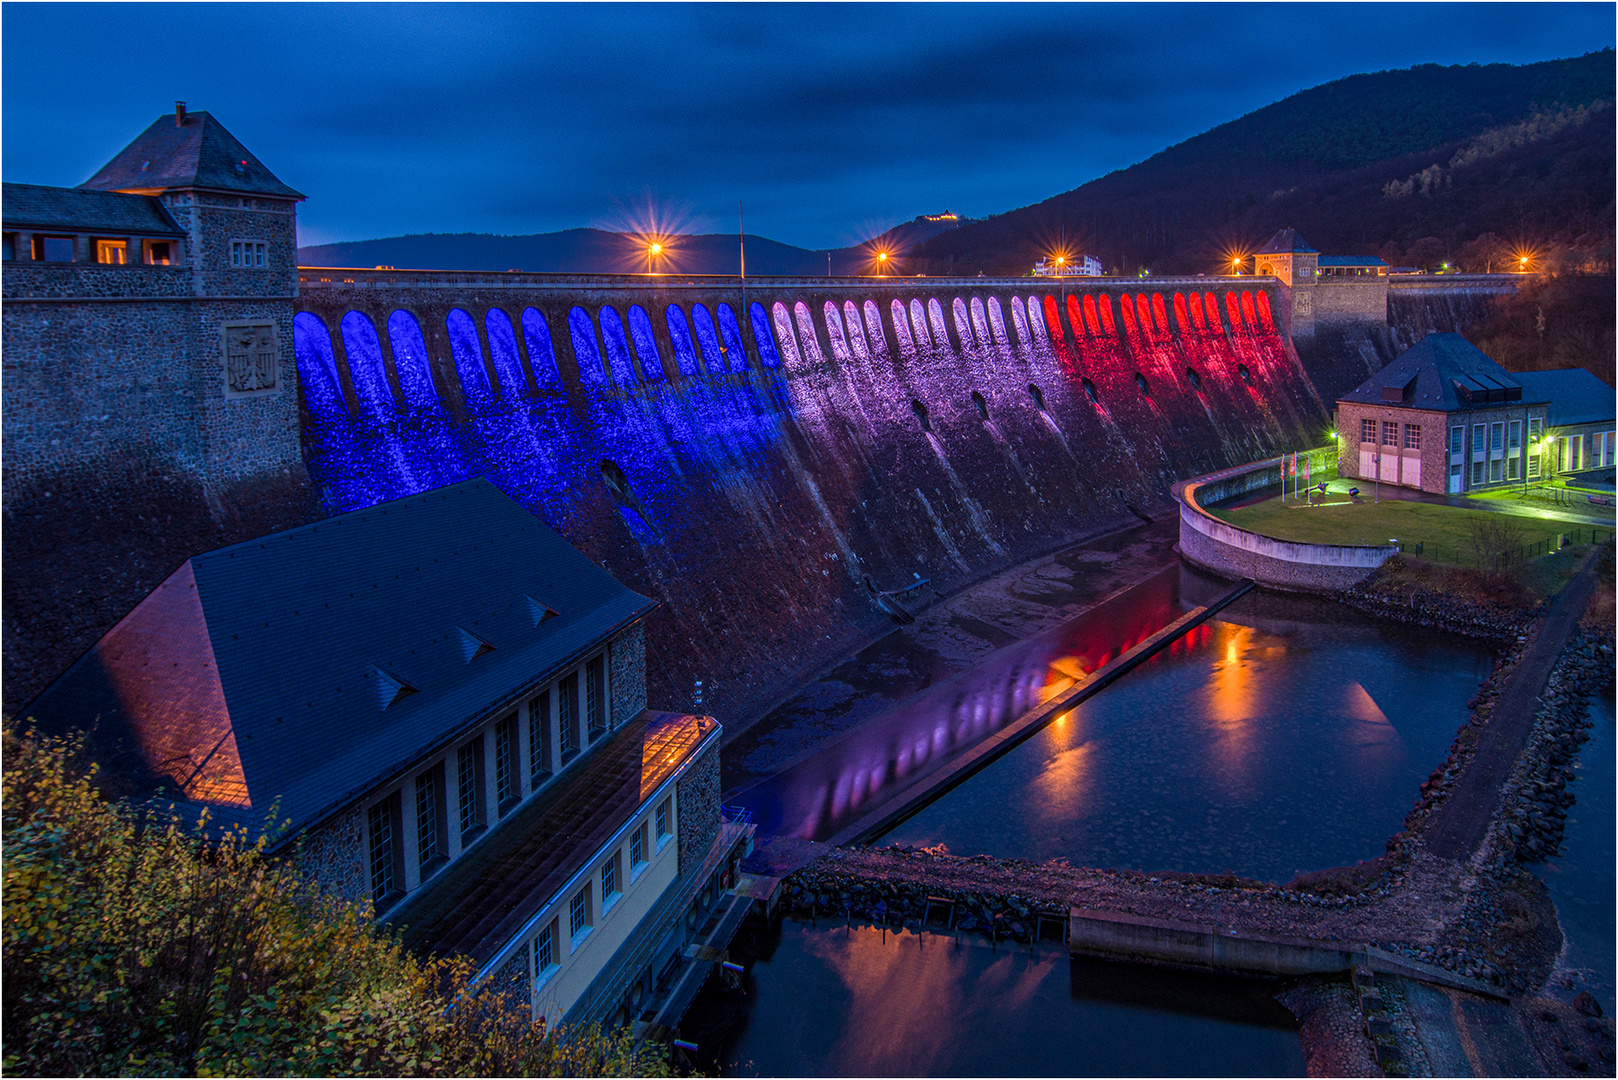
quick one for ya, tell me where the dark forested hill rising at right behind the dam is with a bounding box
[911,49,1615,274]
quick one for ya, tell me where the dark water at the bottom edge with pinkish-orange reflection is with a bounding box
[681,920,1304,1077]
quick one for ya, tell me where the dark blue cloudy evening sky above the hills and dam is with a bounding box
[0,3,1613,248]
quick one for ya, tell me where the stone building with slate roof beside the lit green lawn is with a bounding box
[1336,334,1618,495]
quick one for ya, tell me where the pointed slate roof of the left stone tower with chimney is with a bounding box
[79,112,304,199]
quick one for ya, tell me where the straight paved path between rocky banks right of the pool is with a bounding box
[1427,552,1595,860]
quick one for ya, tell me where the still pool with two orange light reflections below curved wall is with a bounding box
[883,596,1492,881]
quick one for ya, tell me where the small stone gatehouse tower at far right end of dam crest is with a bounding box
[1252,228,1388,340]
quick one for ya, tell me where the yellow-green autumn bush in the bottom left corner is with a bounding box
[0,724,668,1077]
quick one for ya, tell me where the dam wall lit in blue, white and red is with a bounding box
[294,269,1327,730]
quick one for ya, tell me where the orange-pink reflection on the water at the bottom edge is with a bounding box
[806,926,1066,1077]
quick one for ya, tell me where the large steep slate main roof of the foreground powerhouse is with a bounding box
[23,479,654,836]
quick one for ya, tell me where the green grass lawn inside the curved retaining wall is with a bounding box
[1209,499,1573,567]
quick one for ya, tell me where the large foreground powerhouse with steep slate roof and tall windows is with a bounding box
[23,479,751,1025]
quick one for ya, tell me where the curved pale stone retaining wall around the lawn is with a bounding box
[1175,461,1398,593]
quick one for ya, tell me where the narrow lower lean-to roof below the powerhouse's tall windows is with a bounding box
[387,712,718,963]
